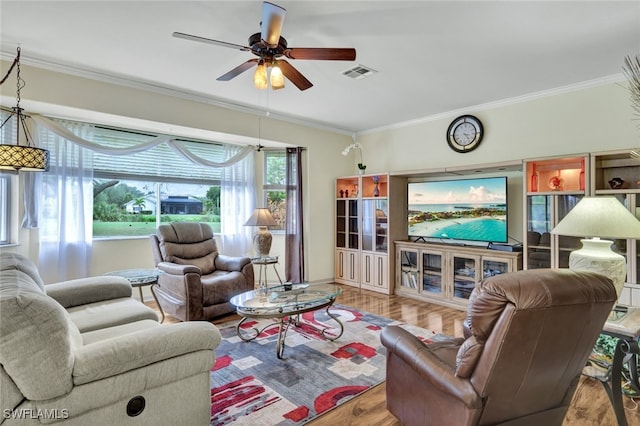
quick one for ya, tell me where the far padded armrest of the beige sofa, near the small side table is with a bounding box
[44,276,131,308]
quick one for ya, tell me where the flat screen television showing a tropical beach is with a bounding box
[407,176,508,243]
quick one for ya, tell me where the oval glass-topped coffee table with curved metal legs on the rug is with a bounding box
[230,284,344,359]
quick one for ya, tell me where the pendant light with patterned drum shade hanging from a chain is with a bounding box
[0,47,49,172]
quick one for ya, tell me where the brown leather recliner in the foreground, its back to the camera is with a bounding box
[381,269,616,426]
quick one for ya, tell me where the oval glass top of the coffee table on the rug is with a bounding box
[230,284,342,315]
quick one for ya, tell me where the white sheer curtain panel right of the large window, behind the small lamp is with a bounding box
[218,146,256,256]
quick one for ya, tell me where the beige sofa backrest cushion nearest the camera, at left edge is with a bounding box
[0,270,82,400]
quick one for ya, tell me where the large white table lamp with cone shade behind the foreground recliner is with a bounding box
[551,197,640,297]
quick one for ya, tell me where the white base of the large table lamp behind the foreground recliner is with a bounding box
[569,238,627,297]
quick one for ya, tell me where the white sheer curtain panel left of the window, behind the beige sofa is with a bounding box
[35,123,93,283]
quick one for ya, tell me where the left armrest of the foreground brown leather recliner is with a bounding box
[380,326,482,408]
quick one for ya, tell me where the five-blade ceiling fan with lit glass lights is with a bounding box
[173,2,356,90]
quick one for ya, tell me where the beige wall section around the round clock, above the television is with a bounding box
[360,83,640,172]
